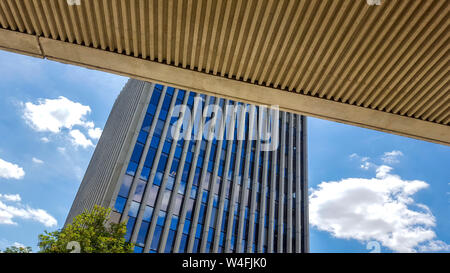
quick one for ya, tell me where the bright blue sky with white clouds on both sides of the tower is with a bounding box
[0,51,450,252]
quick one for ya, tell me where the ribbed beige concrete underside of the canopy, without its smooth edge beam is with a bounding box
[0,0,450,144]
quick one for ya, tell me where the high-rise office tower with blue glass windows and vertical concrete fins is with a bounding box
[66,80,309,253]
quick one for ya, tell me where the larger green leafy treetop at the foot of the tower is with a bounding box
[38,206,133,253]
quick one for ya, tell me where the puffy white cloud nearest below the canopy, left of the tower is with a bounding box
[24,96,91,133]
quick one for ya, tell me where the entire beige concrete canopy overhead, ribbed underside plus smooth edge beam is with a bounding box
[0,0,450,145]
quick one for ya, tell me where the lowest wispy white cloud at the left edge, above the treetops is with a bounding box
[0,195,57,227]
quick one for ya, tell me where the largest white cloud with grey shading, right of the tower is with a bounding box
[309,165,448,252]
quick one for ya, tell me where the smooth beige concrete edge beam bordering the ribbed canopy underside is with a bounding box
[0,30,450,145]
